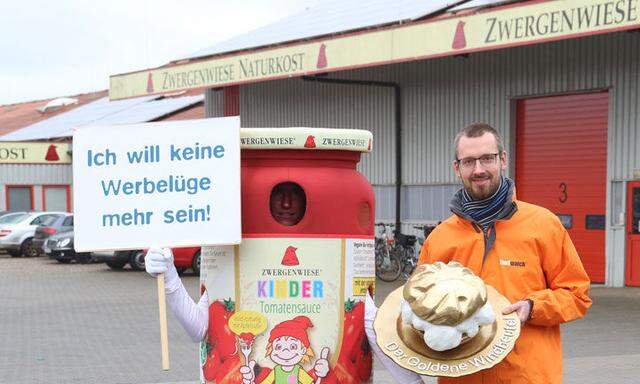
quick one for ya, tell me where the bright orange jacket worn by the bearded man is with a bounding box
[419,200,591,384]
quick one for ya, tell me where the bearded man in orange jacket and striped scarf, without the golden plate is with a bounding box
[419,124,591,384]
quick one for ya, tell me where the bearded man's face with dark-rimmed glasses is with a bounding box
[453,132,507,200]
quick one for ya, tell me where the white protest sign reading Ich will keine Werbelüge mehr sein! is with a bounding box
[73,117,241,252]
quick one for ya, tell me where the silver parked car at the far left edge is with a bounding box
[0,212,67,257]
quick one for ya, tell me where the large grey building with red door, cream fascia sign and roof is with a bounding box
[110,0,640,286]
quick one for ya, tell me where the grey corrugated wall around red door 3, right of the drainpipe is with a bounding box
[338,32,640,184]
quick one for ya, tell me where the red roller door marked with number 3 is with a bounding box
[516,92,609,282]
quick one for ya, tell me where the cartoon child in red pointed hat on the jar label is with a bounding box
[240,316,329,384]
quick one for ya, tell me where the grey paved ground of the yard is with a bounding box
[0,255,640,384]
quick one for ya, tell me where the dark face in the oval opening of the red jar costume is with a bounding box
[269,182,307,226]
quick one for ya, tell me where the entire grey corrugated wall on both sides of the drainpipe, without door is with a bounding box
[208,31,640,286]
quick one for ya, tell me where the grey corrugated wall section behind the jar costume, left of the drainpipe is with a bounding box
[240,79,395,186]
